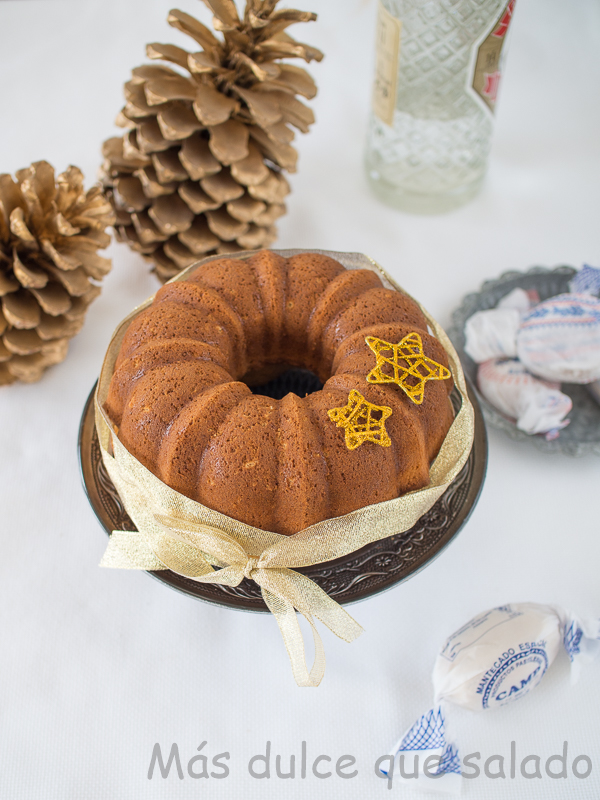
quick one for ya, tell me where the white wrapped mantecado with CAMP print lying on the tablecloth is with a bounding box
[380,603,600,793]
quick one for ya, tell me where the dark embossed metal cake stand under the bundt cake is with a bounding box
[79,370,487,611]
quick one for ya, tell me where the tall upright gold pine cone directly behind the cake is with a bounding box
[101,0,323,281]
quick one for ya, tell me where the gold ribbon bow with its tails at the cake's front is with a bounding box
[101,513,363,686]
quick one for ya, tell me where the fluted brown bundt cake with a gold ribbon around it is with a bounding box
[105,251,453,535]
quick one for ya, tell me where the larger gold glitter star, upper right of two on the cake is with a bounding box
[365,333,450,405]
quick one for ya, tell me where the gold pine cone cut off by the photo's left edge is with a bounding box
[0,161,115,385]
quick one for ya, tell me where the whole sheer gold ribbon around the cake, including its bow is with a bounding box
[95,250,474,686]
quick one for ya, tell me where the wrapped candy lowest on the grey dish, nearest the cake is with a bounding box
[477,358,573,436]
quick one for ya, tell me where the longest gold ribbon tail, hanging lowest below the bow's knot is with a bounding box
[261,586,325,686]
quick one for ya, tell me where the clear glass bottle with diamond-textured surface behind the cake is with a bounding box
[366,0,515,214]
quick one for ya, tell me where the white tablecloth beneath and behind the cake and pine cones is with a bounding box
[0,0,600,800]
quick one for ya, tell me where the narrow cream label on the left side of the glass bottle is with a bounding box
[373,0,402,125]
